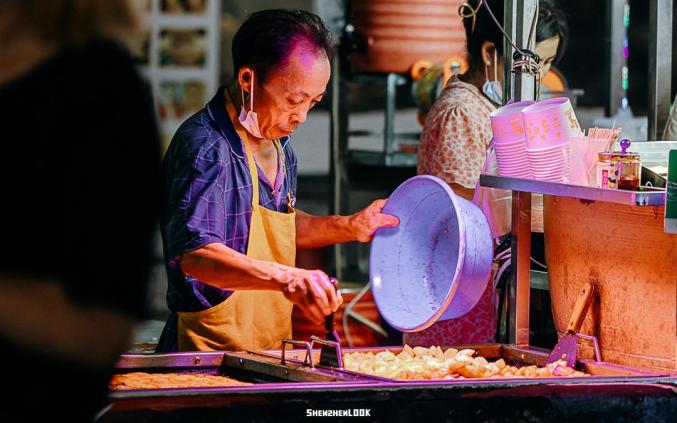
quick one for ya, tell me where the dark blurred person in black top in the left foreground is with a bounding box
[0,0,160,422]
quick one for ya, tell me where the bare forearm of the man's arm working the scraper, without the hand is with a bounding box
[181,243,286,291]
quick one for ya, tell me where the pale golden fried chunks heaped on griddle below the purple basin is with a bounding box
[343,345,589,380]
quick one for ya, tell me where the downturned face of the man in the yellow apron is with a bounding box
[245,41,331,140]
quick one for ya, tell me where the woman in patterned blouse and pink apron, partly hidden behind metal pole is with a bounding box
[412,0,567,345]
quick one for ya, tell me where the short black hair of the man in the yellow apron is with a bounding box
[232,9,334,82]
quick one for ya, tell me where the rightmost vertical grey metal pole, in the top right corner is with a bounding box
[648,0,672,140]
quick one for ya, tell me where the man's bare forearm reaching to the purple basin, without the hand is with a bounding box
[296,210,356,249]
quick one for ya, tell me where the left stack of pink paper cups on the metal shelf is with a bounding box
[490,101,534,179]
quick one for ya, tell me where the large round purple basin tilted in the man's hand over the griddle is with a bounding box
[369,175,493,332]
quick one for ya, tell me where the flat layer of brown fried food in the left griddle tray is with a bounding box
[108,372,251,390]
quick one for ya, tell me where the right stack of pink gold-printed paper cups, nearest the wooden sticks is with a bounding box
[522,97,581,182]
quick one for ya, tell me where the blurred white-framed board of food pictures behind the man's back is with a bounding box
[135,0,221,151]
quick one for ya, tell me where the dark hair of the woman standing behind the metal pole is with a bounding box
[462,0,568,72]
